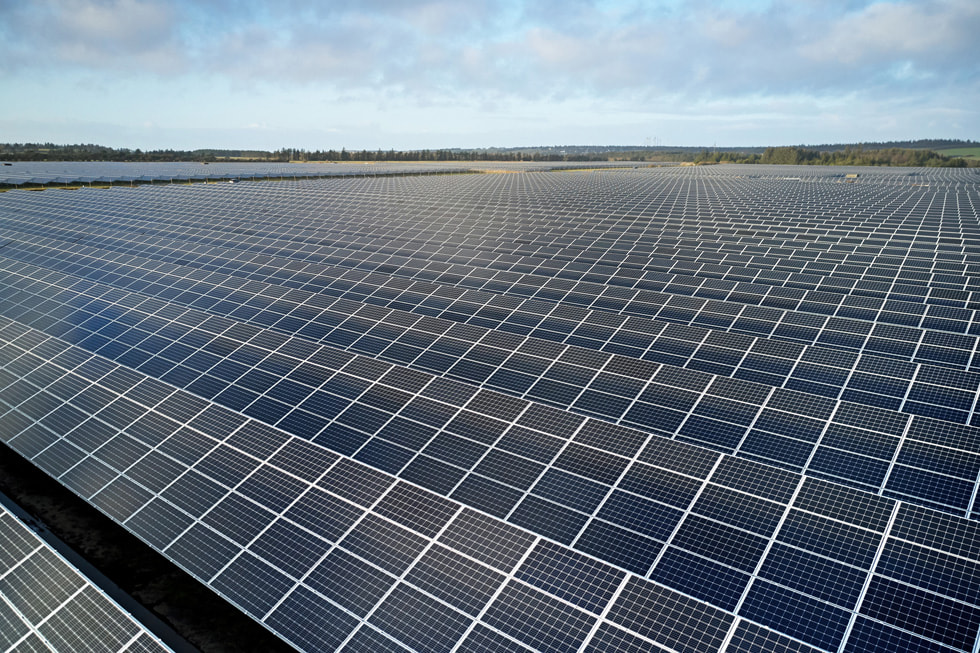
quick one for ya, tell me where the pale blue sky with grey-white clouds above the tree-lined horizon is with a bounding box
[0,0,980,150]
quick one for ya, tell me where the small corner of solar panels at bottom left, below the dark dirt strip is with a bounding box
[0,506,170,653]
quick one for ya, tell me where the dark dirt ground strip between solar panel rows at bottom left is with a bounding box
[0,445,293,653]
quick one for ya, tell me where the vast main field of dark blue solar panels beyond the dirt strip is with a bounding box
[0,166,980,653]
